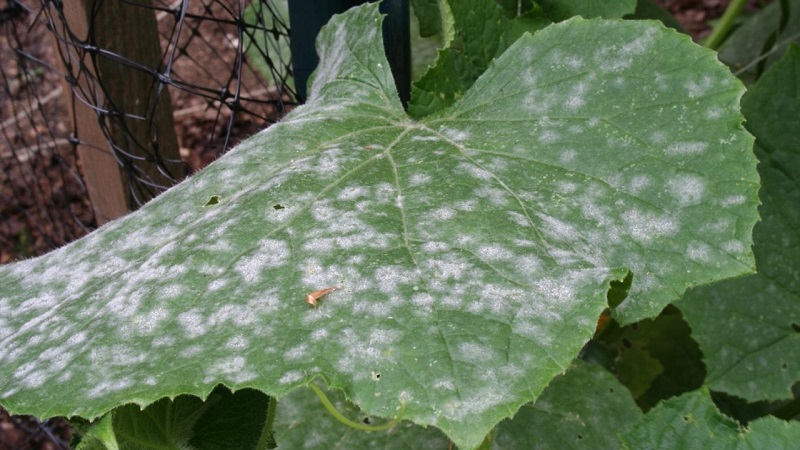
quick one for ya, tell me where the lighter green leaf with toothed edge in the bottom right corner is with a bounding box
[622,389,800,450]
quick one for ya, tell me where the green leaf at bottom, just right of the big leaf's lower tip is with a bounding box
[495,361,642,450]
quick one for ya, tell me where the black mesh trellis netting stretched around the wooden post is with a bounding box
[0,0,295,449]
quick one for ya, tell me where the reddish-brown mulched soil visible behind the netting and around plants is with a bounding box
[0,0,758,450]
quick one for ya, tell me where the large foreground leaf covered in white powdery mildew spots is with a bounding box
[0,5,757,448]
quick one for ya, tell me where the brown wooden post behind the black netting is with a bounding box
[51,0,185,225]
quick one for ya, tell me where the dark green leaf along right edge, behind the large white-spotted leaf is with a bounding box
[679,46,800,401]
